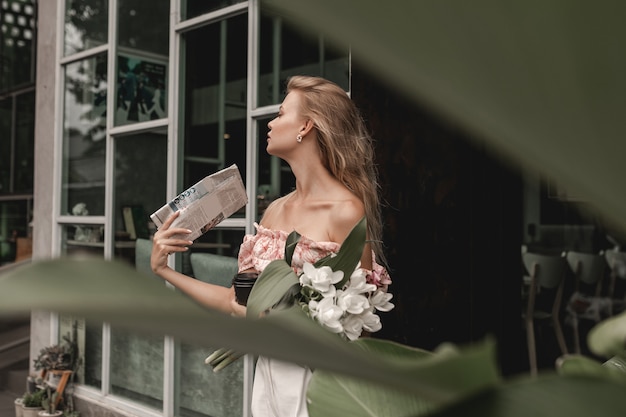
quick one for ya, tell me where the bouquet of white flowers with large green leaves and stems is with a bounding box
[205,218,394,371]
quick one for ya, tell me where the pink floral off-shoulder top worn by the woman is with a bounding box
[238,223,391,287]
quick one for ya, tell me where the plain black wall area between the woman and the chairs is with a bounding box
[352,65,528,374]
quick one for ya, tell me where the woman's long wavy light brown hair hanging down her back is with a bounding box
[287,75,385,265]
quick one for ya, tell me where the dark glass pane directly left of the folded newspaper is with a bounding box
[114,131,168,250]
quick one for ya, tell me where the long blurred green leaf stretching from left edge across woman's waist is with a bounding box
[0,258,497,402]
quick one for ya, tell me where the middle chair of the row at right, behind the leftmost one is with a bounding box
[566,251,608,353]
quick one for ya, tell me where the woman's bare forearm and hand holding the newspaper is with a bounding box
[150,212,246,316]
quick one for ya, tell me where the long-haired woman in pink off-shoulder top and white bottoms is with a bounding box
[151,76,385,417]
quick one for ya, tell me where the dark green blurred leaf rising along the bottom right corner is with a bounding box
[426,373,626,417]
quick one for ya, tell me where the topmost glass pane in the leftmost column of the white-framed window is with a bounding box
[64,0,109,55]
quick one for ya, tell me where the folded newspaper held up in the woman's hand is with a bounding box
[150,164,248,240]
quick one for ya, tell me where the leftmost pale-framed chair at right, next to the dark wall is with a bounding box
[522,251,568,375]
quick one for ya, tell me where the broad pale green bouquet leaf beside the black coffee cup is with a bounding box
[246,255,299,318]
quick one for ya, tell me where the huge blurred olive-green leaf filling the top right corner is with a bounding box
[261,0,626,231]
